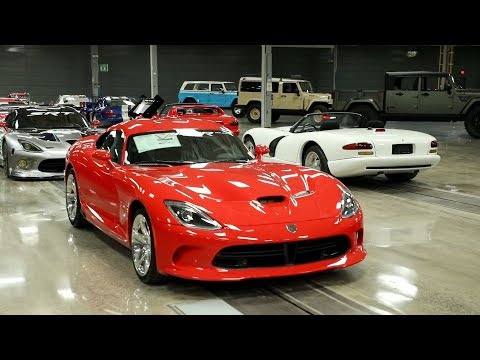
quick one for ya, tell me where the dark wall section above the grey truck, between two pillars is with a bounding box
[336,45,440,90]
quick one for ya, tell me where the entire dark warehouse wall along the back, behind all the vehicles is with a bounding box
[0,45,480,106]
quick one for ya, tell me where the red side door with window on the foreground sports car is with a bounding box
[82,130,125,228]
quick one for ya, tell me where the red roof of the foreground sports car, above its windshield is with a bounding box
[110,118,223,136]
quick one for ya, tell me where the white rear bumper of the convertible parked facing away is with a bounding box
[328,154,440,177]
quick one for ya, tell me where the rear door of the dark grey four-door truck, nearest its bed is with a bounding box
[385,75,420,114]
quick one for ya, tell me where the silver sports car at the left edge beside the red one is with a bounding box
[0,107,98,178]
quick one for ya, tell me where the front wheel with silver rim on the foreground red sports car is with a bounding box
[130,208,169,284]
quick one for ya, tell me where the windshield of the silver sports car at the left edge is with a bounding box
[7,109,88,130]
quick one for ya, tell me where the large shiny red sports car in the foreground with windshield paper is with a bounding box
[65,118,366,283]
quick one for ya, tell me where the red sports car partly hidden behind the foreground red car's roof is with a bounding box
[152,103,240,136]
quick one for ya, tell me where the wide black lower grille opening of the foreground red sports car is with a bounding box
[213,235,350,269]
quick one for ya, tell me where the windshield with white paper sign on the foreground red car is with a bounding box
[124,129,253,165]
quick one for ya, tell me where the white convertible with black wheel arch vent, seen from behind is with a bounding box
[243,112,440,181]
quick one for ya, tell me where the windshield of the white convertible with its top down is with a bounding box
[291,112,363,133]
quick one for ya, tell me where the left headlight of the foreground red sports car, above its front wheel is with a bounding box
[165,200,222,230]
